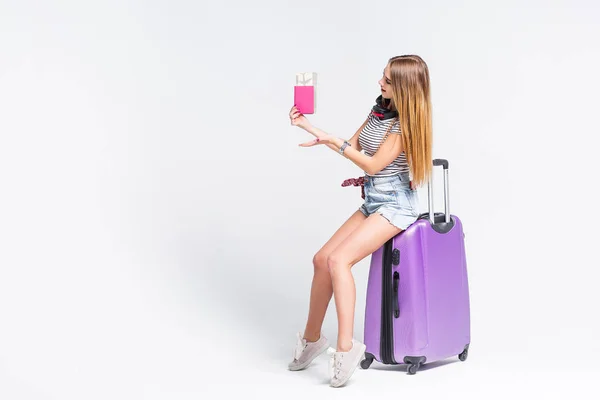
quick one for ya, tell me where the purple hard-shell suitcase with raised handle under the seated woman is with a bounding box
[361,159,470,375]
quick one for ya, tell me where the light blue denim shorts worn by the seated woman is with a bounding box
[359,174,419,230]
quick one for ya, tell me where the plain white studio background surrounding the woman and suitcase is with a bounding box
[0,0,600,400]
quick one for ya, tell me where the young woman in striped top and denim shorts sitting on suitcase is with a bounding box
[289,55,432,387]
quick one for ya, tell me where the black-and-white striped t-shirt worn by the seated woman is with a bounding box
[358,113,409,176]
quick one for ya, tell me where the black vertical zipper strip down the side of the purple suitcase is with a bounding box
[379,238,400,364]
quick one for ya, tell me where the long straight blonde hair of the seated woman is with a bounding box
[388,55,433,186]
